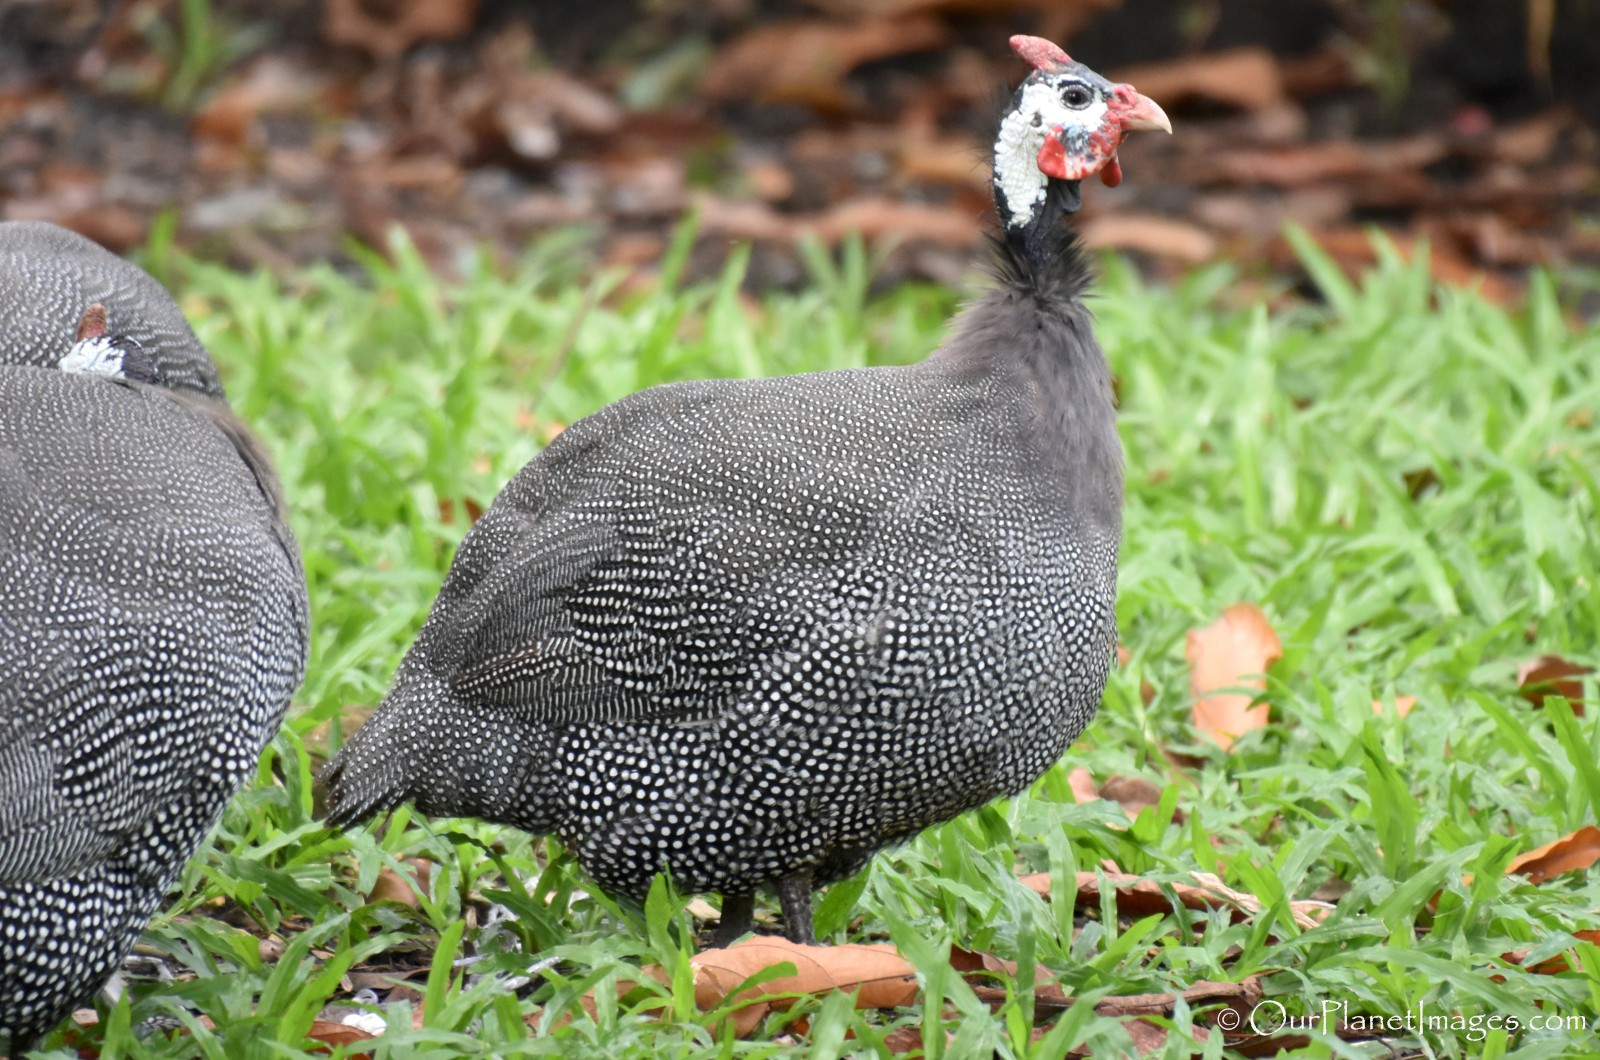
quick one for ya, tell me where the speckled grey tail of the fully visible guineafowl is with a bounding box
[318,666,557,831]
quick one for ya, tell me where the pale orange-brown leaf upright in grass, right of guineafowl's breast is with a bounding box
[1187,604,1283,751]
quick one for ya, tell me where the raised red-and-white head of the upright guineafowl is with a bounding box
[994,35,1173,231]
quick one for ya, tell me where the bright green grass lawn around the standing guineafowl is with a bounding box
[37,219,1600,1058]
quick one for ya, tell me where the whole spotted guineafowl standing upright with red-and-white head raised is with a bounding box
[325,37,1170,942]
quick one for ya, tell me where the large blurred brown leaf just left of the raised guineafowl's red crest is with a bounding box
[701,16,947,110]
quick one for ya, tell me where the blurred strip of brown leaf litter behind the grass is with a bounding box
[0,0,1600,299]
